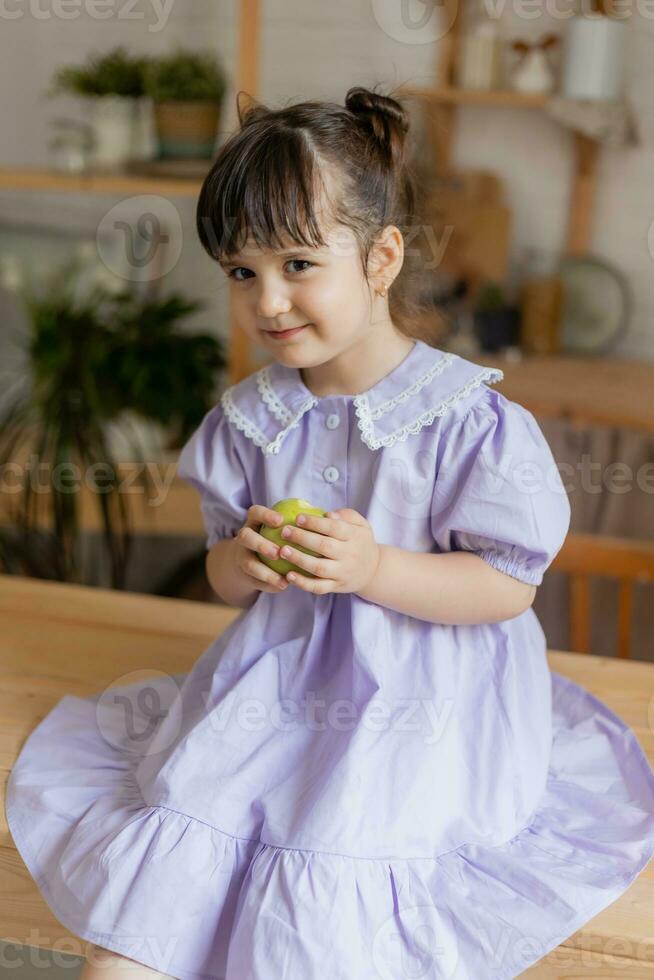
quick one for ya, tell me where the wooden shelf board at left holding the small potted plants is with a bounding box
[0,164,202,197]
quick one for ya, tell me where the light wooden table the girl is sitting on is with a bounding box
[0,575,654,980]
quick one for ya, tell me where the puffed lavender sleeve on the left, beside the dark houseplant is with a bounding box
[177,403,252,550]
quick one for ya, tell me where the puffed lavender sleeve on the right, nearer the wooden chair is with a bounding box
[430,389,571,585]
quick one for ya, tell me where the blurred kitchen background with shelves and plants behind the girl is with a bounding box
[0,0,654,660]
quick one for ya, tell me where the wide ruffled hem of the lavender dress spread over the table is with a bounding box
[6,673,654,980]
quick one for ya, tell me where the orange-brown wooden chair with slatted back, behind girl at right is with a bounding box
[550,532,654,659]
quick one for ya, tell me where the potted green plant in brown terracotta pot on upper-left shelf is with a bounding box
[144,48,227,159]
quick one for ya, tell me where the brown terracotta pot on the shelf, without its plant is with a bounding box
[154,102,221,159]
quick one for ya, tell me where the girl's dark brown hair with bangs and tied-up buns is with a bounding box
[196,86,428,332]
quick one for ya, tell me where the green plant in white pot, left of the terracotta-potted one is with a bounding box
[48,47,151,169]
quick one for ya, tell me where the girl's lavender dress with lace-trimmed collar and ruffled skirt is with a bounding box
[7,341,654,980]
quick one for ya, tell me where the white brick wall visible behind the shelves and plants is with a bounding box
[0,0,654,358]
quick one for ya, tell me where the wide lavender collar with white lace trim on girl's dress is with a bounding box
[220,340,504,455]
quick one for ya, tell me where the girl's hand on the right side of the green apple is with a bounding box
[281,507,381,595]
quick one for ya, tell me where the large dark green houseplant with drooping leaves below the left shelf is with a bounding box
[0,260,225,588]
